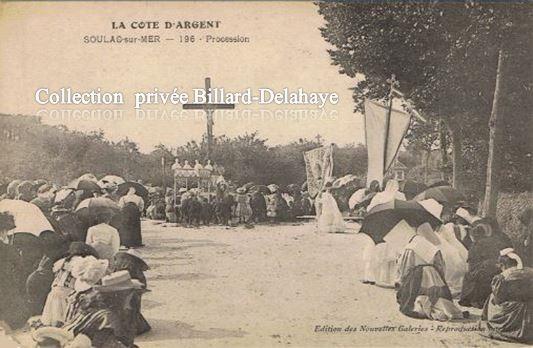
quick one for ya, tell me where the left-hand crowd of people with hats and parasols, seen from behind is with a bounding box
[0,174,151,348]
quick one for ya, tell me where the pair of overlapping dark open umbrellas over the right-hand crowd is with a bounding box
[360,186,464,243]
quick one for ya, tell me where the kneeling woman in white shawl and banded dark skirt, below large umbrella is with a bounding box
[396,235,468,321]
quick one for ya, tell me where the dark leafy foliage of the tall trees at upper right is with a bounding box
[318,1,533,191]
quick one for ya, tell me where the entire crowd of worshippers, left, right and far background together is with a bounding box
[0,174,533,347]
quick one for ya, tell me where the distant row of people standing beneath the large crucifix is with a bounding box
[146,182,315,226]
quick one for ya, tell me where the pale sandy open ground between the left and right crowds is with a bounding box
[136,221,518,347]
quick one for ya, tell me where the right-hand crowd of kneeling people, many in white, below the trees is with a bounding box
[334,180,533,343]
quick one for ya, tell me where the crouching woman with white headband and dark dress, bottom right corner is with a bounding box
[481,248,533,343]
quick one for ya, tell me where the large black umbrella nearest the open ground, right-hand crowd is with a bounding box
[360,199,441,243]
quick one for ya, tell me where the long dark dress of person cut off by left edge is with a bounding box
[0,242,28,328]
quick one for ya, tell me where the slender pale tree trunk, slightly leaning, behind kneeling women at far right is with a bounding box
[481,49,505,217]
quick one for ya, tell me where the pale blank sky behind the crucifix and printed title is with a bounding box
[0,2,364,151]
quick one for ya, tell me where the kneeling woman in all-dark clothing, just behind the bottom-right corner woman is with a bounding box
[459,224,508,308]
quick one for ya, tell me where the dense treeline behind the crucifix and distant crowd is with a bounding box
[0,115,394,186]
